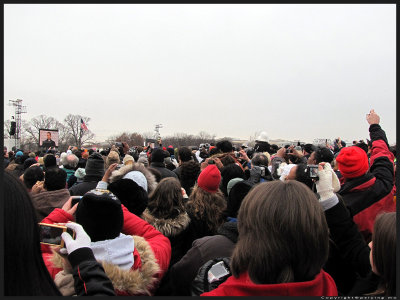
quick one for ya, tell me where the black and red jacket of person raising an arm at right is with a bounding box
[338,124,396,241]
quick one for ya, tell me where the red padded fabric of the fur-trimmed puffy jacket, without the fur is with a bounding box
[41,205,171,295]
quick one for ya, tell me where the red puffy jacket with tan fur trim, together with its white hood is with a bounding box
[42,205,171,295]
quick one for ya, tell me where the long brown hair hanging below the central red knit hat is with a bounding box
[186,184,226,232]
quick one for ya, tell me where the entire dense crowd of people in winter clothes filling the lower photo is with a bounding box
[3,110,396,296]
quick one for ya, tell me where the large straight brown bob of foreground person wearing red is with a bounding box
[231,180,329,284]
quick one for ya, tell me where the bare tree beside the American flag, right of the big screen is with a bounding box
[63,114,94,148]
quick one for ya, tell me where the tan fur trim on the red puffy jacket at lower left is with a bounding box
[51,235,160,296]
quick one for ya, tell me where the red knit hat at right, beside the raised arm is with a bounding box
[336,146,369,178]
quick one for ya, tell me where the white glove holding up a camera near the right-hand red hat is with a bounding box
[315,163,340,201]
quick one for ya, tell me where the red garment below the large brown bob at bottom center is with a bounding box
[201,270,338,297]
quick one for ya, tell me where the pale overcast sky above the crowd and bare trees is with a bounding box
[4,4,396,144]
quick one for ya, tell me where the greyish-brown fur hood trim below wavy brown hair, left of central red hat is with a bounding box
[141,208,190,237]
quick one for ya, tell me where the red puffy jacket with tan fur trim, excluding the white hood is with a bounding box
[42,205,171,295]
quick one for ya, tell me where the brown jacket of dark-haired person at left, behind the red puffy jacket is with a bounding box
[32,189,70,222]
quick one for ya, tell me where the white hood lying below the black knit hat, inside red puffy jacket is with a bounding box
[90,233,135,270]
